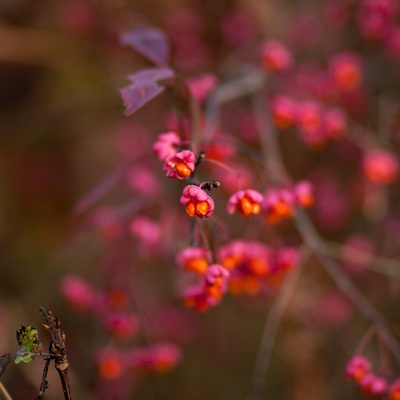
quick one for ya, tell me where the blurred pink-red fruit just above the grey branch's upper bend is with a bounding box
[261,40,293,72]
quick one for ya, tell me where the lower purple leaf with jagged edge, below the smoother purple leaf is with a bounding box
[119,68,174,116]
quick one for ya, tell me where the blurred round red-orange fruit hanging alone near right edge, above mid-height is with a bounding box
[362,150,399,184]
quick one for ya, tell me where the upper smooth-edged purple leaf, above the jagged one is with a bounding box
[121,28,170,67]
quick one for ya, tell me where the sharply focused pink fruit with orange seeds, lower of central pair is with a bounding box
[180,185,215,218]
